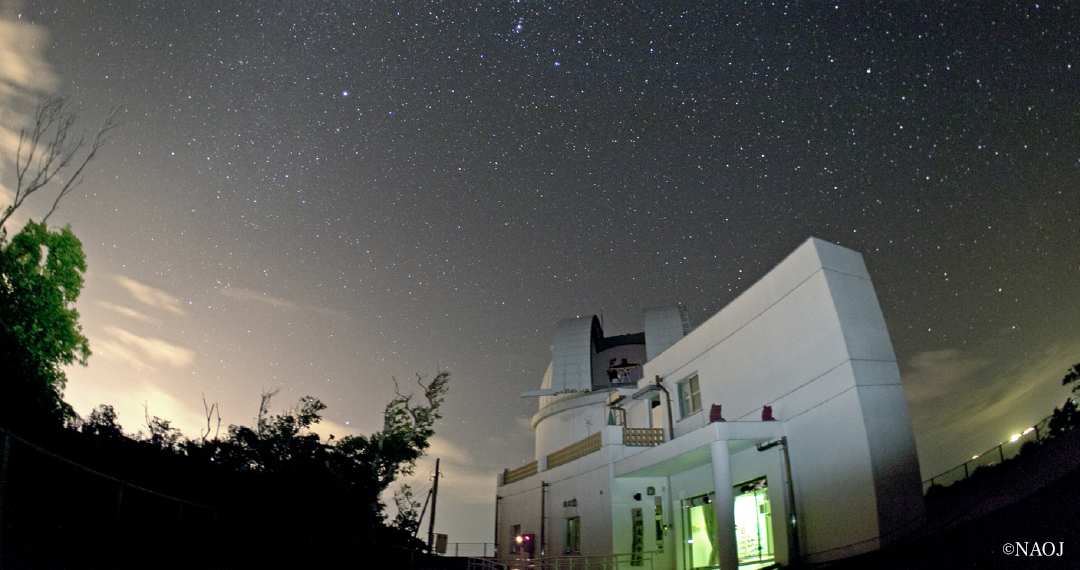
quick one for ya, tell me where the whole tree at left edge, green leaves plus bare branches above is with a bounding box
[0,98,122,430]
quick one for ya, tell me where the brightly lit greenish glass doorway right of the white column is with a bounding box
[734,477,775,570]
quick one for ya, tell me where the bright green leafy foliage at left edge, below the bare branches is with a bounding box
[0,220,90,428]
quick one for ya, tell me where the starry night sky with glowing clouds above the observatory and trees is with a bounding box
[0,0,1080,543]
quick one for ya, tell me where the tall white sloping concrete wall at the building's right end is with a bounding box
[640,240,922,561]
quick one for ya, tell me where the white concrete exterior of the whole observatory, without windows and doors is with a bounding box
[499,239,924,568]
